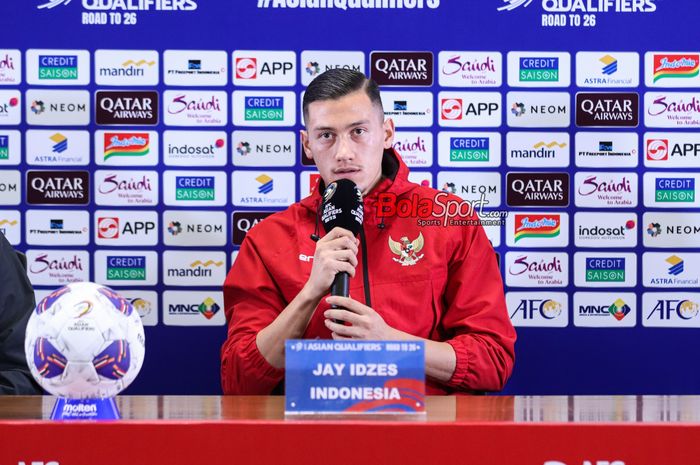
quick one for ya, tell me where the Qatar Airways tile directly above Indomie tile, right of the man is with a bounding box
[506,173,569,207]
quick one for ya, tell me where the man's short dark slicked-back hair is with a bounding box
[302,68,382,121]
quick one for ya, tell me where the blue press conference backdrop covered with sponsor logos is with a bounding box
[0,0,700,394]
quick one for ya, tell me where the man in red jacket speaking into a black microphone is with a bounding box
[221,69,515,394]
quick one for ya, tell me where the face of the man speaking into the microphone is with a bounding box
[301,90,394,194]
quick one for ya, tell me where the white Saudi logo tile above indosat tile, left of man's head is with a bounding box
[163,91,228,126]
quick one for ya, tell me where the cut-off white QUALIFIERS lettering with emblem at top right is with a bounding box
[497,0,656,13]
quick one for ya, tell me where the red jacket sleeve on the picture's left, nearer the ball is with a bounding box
[221,234,287,395]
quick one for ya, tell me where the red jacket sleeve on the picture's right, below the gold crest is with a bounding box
[442,221,516,391]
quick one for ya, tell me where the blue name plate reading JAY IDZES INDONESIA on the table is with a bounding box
[285,339,425,414]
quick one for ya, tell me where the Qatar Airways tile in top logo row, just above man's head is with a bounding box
[370,52,433,86]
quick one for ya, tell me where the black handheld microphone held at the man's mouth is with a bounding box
[321,179,364,307]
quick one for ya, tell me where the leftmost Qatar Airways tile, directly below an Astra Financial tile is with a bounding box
[27,171,90,205]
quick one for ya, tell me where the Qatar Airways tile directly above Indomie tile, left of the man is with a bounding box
[95,91,158,125]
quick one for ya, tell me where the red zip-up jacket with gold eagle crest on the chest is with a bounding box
[221,150,515,395]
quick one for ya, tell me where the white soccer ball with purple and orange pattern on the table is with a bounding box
[24,282,146,399]
